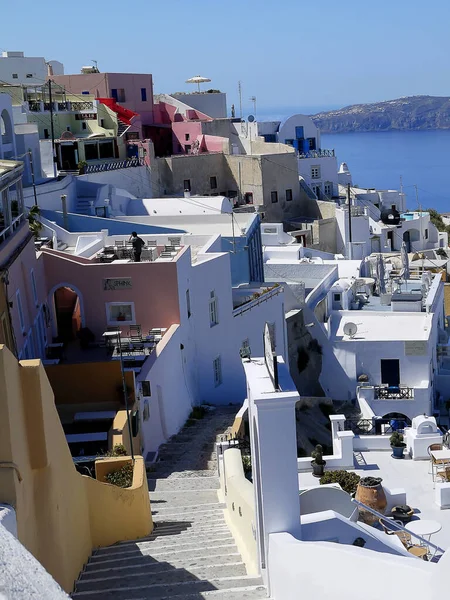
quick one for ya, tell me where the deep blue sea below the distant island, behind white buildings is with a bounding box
[321,130,450,213]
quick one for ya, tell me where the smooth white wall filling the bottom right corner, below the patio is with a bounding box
[269,533,436,600]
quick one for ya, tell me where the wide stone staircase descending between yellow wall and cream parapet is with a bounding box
[72,407,267,600]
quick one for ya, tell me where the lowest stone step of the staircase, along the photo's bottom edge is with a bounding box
[72,575,264,600]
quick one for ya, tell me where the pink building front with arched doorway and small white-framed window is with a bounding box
[43,248,185,341]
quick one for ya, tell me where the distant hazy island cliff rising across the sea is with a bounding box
[311,96,450,133]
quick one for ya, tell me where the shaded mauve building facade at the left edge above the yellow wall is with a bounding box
[0,161,50,359]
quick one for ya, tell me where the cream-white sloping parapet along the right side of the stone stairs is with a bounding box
[218,444,258,573]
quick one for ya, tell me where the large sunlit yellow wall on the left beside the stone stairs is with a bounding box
[0,346,153,591]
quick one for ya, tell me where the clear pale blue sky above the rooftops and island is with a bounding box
[0,0,450,116]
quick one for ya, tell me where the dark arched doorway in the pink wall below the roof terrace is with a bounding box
[49,283,84,342]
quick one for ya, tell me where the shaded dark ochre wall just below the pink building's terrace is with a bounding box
[45,360,134,406]
